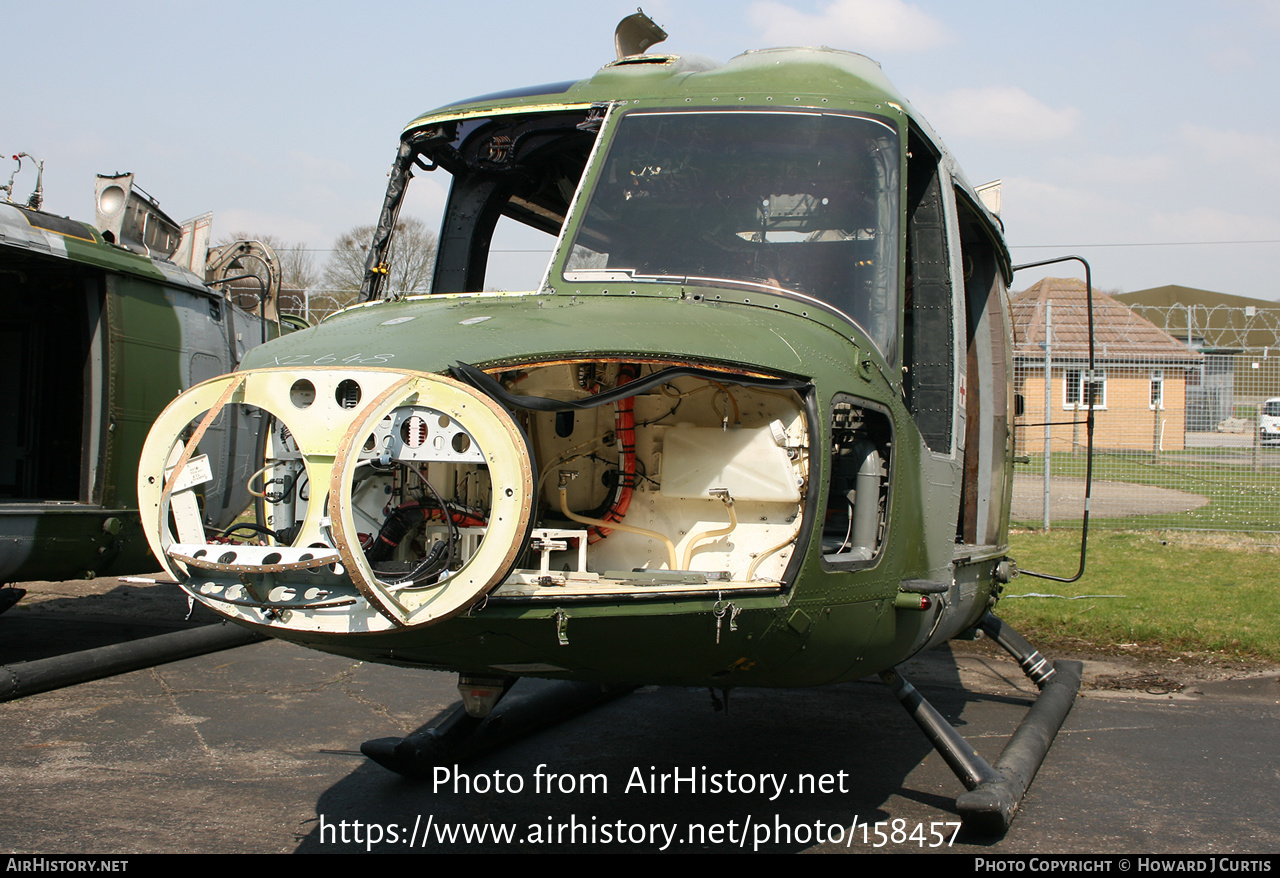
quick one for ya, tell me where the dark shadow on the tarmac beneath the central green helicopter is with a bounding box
[297,650,1008,854]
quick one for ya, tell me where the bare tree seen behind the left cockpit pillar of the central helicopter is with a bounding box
[321,216,435,303]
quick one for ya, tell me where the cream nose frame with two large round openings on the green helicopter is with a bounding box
[138,369,534,634]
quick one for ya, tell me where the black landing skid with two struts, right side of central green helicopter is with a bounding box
[881,613,1083,834]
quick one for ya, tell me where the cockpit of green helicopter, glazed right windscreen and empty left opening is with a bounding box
[389,108,901,362]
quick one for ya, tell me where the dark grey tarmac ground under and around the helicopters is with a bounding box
[0,581,1280,854]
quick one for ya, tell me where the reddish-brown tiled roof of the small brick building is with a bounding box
[1011,278,1203,363]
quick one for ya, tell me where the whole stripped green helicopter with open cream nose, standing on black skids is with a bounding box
[138,14,1079,829]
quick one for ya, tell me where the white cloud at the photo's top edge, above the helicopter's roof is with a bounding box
[746,0,951,52]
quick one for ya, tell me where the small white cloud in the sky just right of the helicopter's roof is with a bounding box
[914,86,1082,141]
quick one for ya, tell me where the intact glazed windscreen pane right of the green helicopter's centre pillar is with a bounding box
[563,110,900,362]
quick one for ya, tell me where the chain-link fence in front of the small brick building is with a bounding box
[1012,348,1280,539]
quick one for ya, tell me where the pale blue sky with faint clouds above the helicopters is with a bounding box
[10,0,1280,299]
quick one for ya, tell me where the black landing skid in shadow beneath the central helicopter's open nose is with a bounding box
[360,680,635,778]
